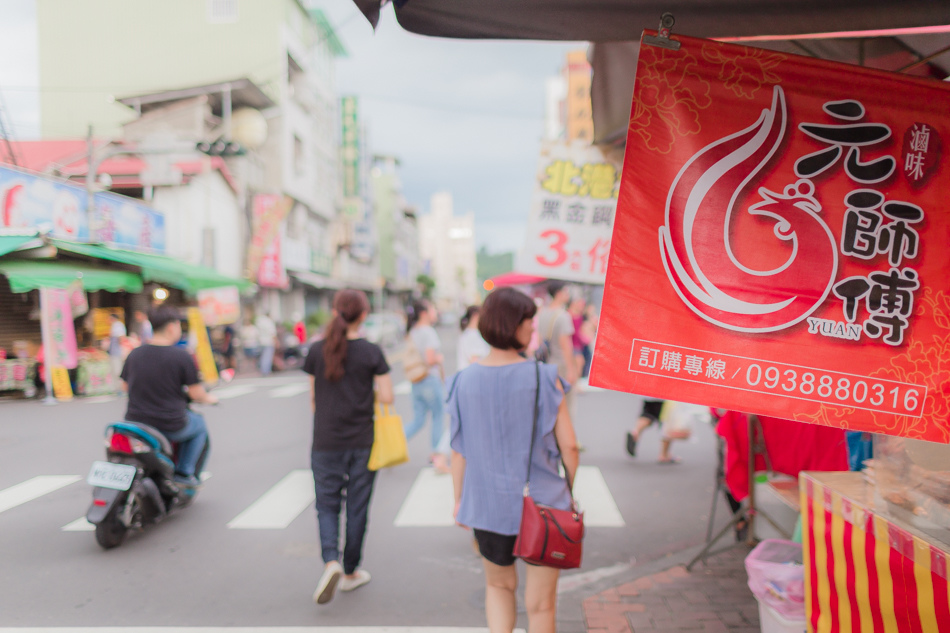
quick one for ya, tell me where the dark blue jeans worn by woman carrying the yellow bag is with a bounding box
[310,448,376,574]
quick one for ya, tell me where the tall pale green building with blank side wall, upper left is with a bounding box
[37,0,368,320]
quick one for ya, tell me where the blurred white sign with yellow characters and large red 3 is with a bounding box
[518,142,622,284]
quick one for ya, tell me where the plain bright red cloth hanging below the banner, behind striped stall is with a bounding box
[716,411,848,501]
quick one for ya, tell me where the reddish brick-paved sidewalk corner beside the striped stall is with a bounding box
[558,546,759,633]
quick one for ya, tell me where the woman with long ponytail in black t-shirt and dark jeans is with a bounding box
[303,289,394,604]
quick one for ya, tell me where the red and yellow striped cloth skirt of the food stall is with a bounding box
[800,473,950,633]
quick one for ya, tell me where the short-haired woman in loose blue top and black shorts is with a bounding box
[448,288,578,633]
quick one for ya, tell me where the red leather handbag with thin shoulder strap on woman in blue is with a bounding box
[514,365,584,569]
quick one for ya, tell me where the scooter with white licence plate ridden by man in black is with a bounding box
[86,422,210,549]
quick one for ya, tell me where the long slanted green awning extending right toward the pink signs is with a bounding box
[53,240,253,294]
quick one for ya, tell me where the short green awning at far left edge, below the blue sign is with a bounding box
[0,259,142,292]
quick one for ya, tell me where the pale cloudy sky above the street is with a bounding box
[0,0,586,252]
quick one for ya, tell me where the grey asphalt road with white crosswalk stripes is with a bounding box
[0,330,736,631]
